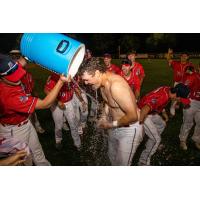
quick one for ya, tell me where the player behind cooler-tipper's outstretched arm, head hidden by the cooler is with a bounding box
[44,73,84,150]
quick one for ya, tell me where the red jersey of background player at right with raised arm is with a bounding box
[170,60,192,82]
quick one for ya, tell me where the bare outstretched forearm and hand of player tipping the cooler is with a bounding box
[35,75,70,109]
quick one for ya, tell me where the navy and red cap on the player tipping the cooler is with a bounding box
[0,54,26,82]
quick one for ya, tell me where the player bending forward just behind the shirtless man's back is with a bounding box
[138,83,190,165]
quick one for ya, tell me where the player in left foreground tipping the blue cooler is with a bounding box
[0,55,69,165]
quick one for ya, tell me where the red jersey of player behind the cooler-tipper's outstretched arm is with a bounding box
[45,74,76,103]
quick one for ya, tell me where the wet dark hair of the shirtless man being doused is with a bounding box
[79,58,107,75]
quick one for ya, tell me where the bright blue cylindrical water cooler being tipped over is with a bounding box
[20,33,85,77]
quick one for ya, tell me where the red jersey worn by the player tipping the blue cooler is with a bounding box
[0,81,37,125]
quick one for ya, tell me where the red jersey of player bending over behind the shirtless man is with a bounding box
[138,86,170,113]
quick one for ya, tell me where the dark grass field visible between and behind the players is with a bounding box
[29,59,200,166]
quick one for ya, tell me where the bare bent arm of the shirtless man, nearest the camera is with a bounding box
[111,81,138,127]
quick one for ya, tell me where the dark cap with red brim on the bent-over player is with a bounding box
[171,83,190,105]
